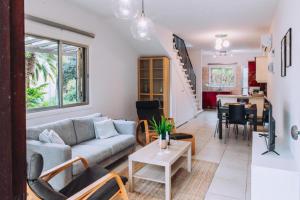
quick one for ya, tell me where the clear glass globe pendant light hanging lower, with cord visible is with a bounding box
[131,0,154,40]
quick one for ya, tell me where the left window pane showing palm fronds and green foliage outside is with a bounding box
[25,36,58,109]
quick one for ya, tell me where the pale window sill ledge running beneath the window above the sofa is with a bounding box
[26,104,92,120]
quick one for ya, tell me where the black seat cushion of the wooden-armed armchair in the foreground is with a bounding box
[60,165,127,200]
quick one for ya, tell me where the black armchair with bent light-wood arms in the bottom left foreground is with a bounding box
[27,151,128,200]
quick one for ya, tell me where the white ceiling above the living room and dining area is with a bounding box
[68,0,279,50]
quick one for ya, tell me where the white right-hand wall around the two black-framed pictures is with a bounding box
[268,0,300,166]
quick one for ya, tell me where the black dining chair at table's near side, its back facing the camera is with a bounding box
[224,104,247,143]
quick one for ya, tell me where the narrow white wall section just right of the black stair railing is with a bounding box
[188,49,202,108]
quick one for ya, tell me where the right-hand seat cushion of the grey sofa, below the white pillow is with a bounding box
[82,135,135,155]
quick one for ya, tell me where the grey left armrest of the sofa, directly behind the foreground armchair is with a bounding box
[27,140,72,190]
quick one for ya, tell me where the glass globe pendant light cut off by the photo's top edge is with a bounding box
[112,0,138,20]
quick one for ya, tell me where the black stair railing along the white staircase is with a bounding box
[173,34,196,94]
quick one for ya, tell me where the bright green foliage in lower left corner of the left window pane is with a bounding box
[26,83,48,108]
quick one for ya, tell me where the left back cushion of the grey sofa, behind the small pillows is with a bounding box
[27,119,76,146]
